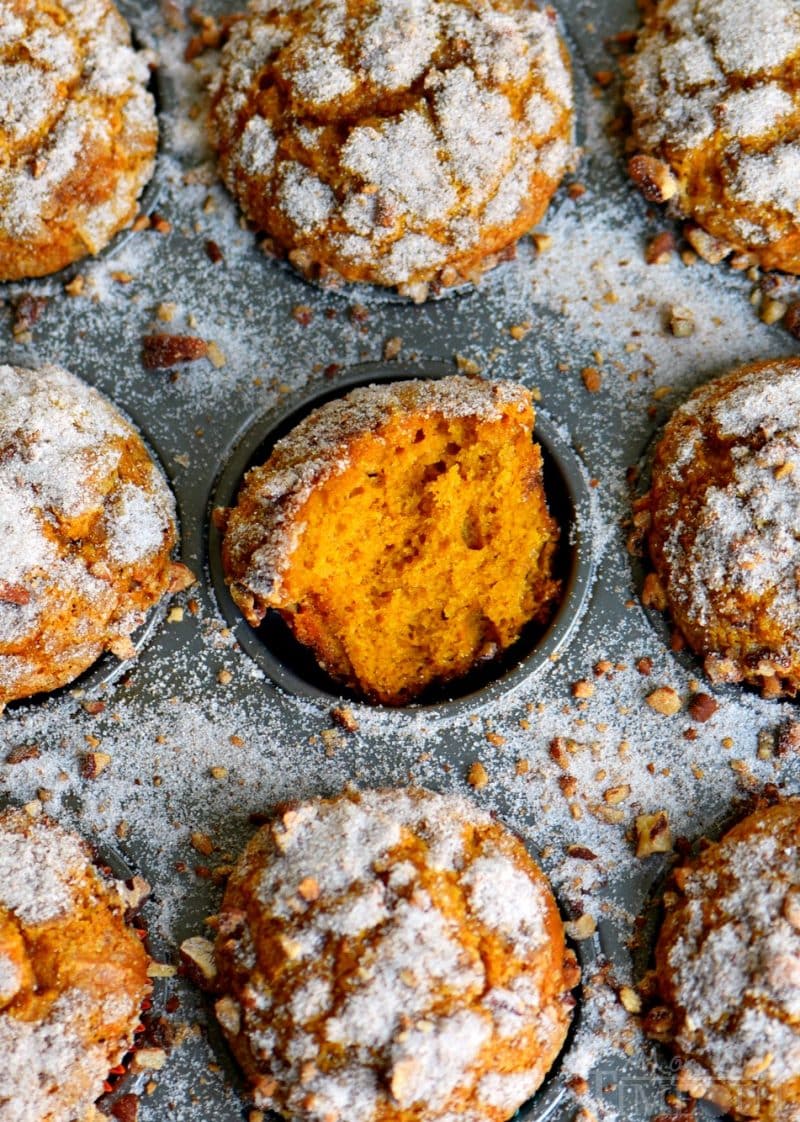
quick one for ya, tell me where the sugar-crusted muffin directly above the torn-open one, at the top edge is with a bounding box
[211,0,572,300]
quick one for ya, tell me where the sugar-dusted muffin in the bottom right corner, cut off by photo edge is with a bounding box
[655,799,800,1122]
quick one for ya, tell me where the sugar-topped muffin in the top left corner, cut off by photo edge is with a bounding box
[0,0,158,281]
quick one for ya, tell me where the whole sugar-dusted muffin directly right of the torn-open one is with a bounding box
[645,359,800,697]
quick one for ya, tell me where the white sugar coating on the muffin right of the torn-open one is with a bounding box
[658,364,800,657]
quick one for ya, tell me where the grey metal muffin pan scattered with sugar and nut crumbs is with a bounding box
[0,0,800,1122]
